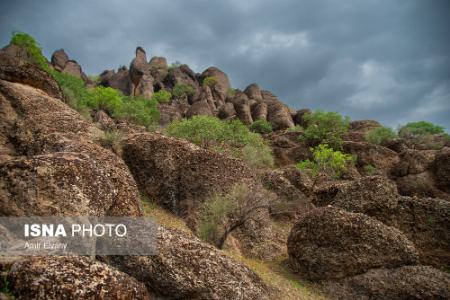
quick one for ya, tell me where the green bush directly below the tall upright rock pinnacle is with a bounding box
[113,96,160,130]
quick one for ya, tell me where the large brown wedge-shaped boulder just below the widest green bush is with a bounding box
[123,134,253,214]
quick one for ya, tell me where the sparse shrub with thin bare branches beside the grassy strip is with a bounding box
[197,184,268,249]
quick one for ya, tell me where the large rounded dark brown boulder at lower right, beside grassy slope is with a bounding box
[288,207,418,280]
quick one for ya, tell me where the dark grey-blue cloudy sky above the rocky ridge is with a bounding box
[0,0,450,132]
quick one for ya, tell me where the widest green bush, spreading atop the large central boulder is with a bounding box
[166,116,273,167]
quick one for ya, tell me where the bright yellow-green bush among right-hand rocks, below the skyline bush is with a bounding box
[297,144,355,179]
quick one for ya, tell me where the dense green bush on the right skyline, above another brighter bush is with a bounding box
[301,110,350,149]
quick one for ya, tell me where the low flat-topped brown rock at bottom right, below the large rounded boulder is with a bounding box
[325,266,450,300]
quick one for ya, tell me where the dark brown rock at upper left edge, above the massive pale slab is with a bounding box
[0,51,63,99]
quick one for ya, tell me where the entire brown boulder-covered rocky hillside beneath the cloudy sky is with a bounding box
[0,35,450,299]
